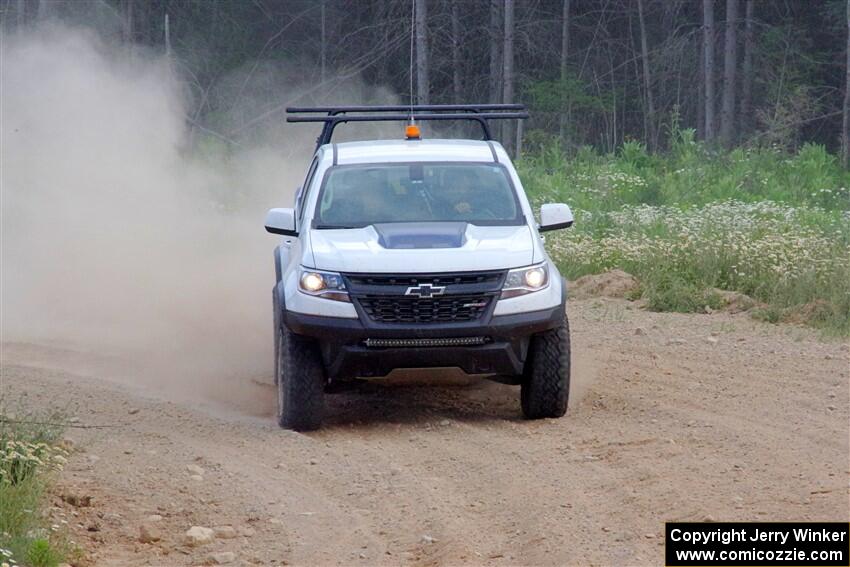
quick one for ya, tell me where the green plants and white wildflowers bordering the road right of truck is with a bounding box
[518,130,850,336]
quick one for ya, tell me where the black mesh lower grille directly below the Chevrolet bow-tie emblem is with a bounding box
[357,294,492,323]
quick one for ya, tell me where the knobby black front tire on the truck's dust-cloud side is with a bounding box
[277,325,325,431]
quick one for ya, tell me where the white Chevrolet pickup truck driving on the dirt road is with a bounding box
[265,105,573,431]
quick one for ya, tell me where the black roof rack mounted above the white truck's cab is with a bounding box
[286,104,528,149]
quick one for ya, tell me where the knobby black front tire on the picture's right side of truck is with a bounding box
[520,314,570,419]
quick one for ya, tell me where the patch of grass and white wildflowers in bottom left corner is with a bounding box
[0,399,73,567]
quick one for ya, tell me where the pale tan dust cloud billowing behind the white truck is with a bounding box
[0,23,328,404]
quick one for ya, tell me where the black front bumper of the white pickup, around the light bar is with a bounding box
[283,302,564,380]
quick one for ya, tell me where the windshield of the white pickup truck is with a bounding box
[314,163,523,228]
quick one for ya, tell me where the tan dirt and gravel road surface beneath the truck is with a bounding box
[1,299,850,566]
